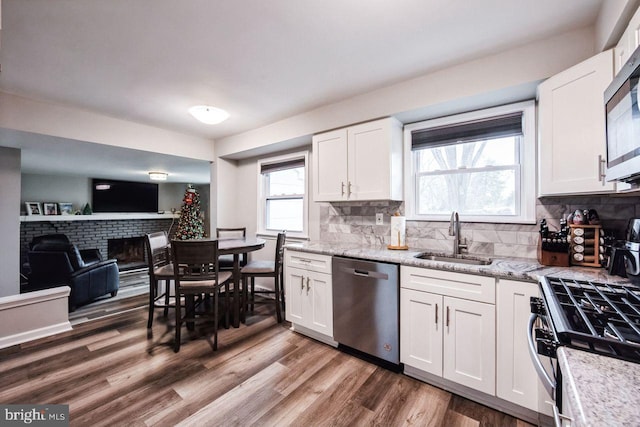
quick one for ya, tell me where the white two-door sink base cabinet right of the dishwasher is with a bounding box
[400,266,496,395]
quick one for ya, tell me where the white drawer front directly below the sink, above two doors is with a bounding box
[400,265,496,304]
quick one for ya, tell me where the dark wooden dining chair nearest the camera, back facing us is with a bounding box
[171,240,232,353]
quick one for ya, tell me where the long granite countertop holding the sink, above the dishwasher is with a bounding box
[285,241,628,283]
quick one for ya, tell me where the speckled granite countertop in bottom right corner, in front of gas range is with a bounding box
[558,347,640,427]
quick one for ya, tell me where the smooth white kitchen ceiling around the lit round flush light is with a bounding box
[0,0,603,182]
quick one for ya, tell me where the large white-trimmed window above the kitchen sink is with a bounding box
[405,101,536,223]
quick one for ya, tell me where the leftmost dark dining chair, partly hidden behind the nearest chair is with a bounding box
[145,231,175,329]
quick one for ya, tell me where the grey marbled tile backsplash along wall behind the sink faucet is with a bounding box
[320,195,640,259]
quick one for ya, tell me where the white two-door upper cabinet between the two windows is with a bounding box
[313,118,402,202]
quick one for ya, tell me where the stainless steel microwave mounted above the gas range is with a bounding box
[604,47,640,183]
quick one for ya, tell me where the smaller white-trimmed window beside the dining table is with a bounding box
[258,152,308,237]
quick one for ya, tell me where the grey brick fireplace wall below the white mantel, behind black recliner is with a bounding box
[20,217,172,270]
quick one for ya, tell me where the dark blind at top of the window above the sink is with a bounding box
[411,112,522,150]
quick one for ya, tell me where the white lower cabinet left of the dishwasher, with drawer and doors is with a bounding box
[284,251,333,338]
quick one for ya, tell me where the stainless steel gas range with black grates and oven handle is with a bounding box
[529,277,640,423]
